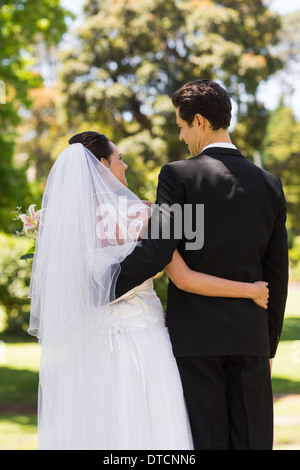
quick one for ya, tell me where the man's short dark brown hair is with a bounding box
[172,79,231,131]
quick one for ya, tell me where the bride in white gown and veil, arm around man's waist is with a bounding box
[28,132,268,450]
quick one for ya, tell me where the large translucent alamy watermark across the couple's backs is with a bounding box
[96,197,204,250]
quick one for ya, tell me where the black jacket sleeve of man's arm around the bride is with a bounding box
[115,164,184,298]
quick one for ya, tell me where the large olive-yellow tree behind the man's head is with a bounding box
[60,0,281,174]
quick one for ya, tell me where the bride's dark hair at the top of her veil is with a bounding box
[69,131,113,160]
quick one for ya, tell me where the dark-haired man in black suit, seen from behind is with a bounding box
[116,80,288,450]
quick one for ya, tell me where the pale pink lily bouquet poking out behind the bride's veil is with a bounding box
[16,204,41,259]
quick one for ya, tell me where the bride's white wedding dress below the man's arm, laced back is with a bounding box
[39,279,193,450]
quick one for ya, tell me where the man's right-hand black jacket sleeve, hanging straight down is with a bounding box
[262,178,288,358]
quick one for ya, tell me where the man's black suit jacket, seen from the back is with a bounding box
[116,147,288,357]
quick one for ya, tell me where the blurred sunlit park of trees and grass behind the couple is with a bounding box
[0,0,300,450]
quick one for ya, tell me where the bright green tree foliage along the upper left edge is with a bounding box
[0,0,68,232]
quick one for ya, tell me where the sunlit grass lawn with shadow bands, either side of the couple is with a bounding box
[0,288,300,450]
